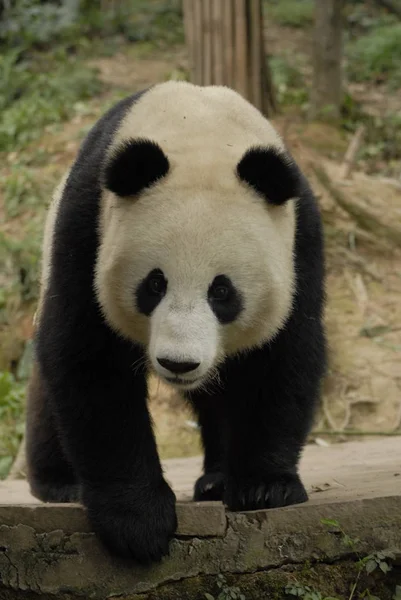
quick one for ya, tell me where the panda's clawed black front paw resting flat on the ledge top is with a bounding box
[224,473,308,511]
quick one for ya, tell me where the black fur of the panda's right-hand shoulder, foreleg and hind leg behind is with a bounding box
[188,171,326,510]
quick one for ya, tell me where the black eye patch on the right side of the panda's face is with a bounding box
[207,275,243,324]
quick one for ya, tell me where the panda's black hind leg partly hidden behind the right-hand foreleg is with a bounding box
[191,392,226,502]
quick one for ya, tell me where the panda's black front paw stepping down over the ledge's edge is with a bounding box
[83,480,177,564]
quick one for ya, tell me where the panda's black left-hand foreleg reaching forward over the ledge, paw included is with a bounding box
[37,322,177,563]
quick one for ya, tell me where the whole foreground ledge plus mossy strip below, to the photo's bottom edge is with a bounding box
[0,437,401,600]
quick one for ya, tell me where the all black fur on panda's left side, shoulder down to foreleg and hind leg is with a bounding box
[27,88,176,562]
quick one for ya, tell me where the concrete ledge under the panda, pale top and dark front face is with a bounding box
[0,439,401,600]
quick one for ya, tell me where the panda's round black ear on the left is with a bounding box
[104,139,170,197]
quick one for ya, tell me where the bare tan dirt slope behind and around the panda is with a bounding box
[0,12,401,468]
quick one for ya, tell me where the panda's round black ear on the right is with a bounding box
[237,146,301,205]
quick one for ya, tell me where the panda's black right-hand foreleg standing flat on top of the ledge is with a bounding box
[220,322,325,510]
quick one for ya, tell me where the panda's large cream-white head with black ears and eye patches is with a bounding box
[96,82,300,389]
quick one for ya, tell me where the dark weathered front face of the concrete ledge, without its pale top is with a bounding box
[0,496,401,599]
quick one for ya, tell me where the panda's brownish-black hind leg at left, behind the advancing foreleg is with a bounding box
[25,362,79,502]
